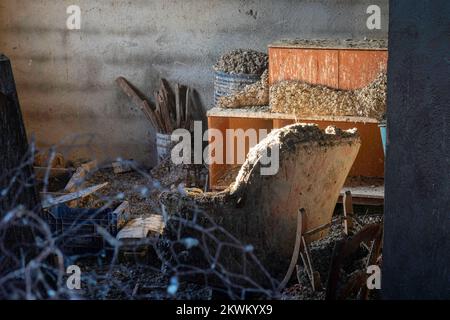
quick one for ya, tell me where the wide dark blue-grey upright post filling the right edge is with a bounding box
[381,0,450,300]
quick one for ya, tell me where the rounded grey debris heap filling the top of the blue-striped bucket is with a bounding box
[214,49,269,75]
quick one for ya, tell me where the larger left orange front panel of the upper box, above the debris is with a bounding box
[269,48,339,88]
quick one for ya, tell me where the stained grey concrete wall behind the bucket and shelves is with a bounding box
[0,0,388,165]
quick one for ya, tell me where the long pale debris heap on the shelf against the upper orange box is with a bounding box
[270,72,387,119]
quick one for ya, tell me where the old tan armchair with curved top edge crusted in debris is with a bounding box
[161,124,361,289]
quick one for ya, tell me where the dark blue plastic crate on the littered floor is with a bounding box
[45,205,127,253]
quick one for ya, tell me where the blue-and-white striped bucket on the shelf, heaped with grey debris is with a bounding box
[214,71,261,105]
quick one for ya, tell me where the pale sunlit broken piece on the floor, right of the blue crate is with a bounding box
[116,214,164,240]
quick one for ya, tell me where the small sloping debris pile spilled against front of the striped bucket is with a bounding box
[217,70,269,108]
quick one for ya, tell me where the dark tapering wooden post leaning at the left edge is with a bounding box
[0,54,41,214]
